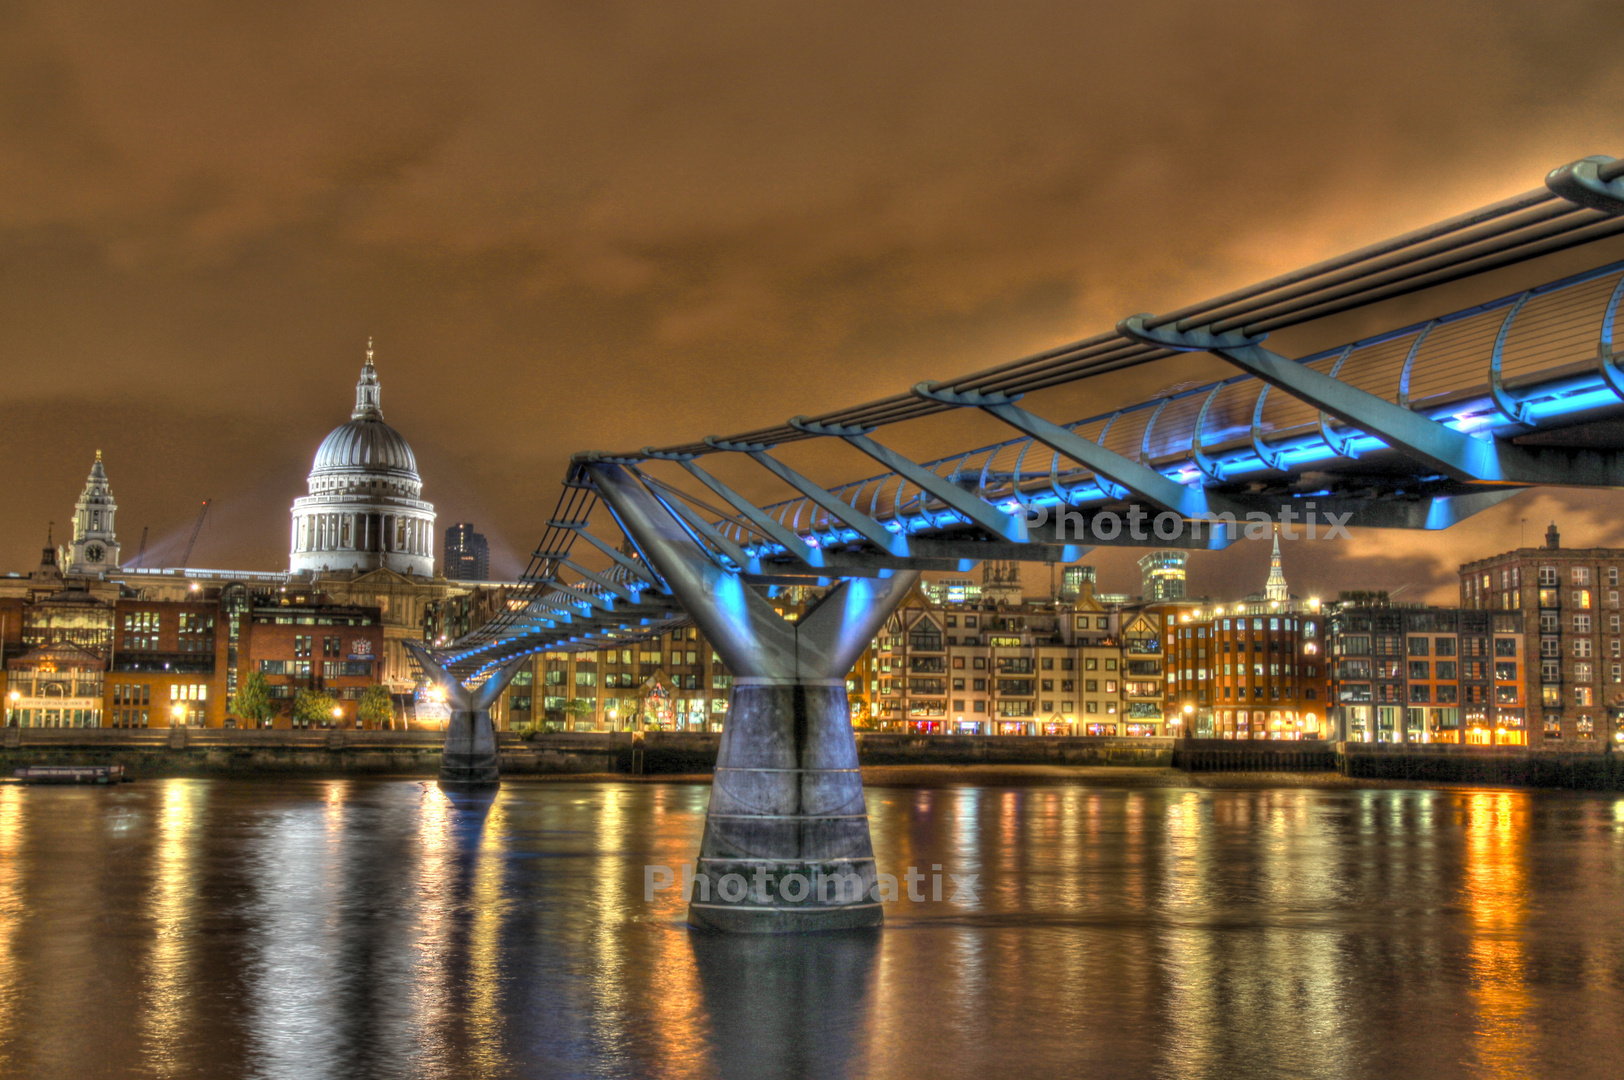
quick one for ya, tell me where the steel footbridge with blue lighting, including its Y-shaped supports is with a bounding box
[416,156,1624,932]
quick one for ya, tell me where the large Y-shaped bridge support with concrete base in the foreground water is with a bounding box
[586,463,919,934]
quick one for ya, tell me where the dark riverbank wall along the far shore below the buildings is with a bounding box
[0,728,1624,791]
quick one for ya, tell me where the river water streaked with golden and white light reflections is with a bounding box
[0,780,1624,1080]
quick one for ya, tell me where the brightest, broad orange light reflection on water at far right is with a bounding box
[1465,791,1535,1077]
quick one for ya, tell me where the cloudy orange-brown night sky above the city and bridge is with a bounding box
[0,0,1624,601]
